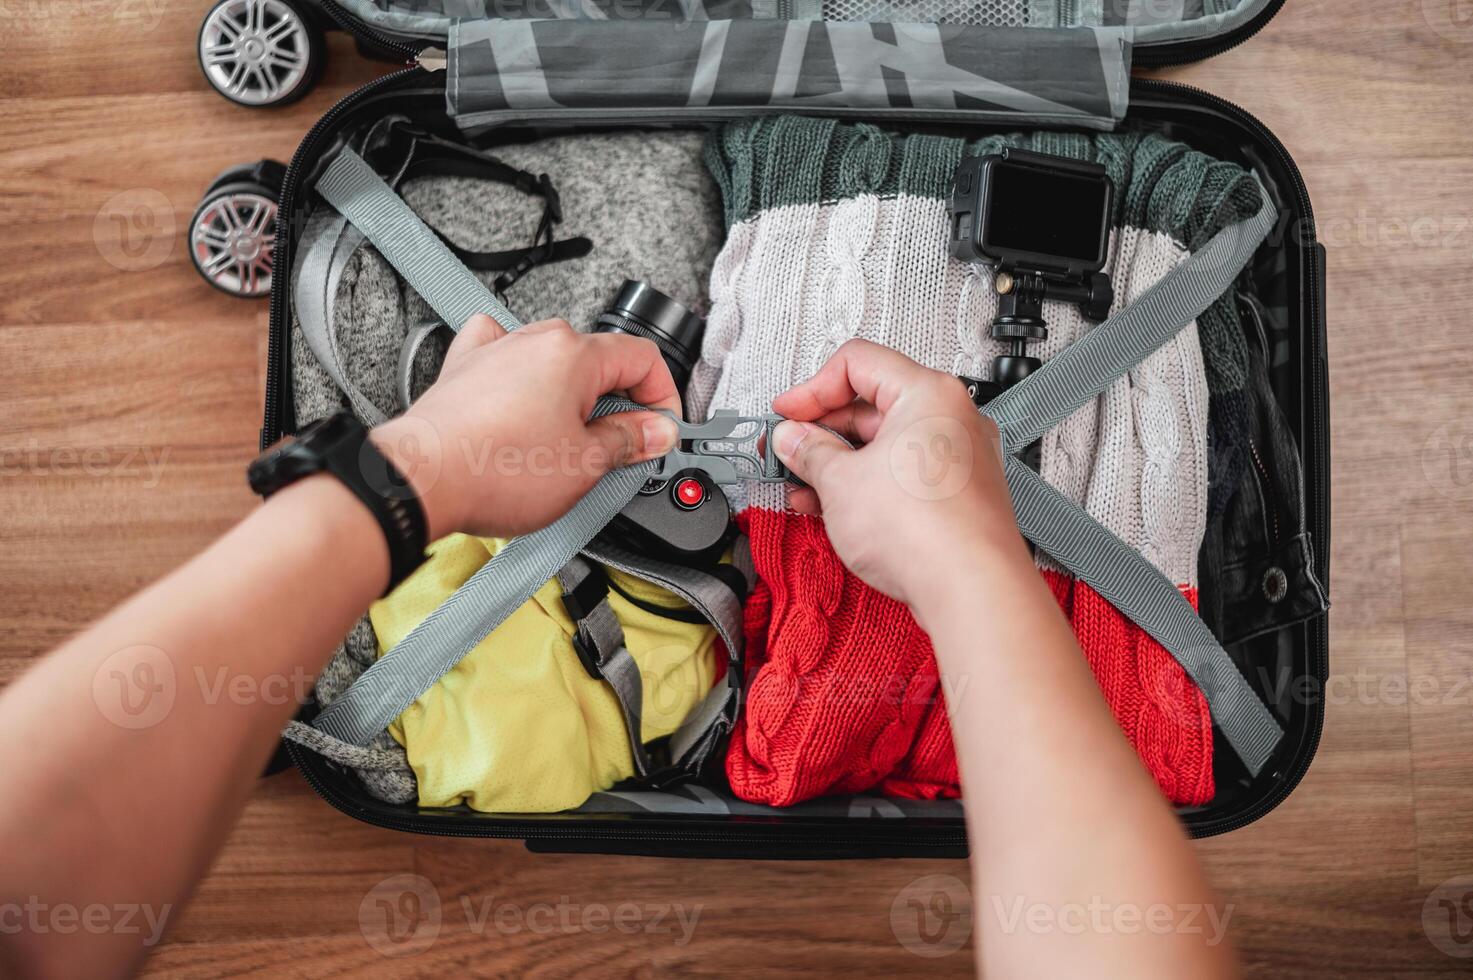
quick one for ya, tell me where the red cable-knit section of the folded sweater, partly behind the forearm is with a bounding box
[726,508,1212,806]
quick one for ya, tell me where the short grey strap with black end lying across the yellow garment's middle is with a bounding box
[557,556,650,777]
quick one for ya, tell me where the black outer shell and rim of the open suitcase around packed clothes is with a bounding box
[191,0,1330,858]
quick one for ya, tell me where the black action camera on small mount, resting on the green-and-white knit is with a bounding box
[950,147,1115,388]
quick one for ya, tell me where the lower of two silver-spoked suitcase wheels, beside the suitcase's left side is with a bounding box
[189,161,286,298]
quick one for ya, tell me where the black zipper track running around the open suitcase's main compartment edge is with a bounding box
[261,72,1329,847]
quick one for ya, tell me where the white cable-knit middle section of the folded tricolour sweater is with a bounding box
[686,195,1206,587]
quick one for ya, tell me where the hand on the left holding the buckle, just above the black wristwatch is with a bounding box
[371,315,681,541]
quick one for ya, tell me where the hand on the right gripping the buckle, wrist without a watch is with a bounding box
[772,340,1031,606]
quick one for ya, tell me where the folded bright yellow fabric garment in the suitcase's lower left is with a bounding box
[368,535,723,813]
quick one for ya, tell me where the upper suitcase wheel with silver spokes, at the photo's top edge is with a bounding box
[199,0,326,106]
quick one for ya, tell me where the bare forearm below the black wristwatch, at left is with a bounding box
[0,476,387,976]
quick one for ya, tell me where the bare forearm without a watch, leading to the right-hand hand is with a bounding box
[916,547,1234,977]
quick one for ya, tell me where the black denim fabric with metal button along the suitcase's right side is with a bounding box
[1198,296,1330,645]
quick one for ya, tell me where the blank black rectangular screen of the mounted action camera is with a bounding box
[982,161,1108,262]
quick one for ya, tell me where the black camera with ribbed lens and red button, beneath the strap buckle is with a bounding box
[594,279,732,564]
